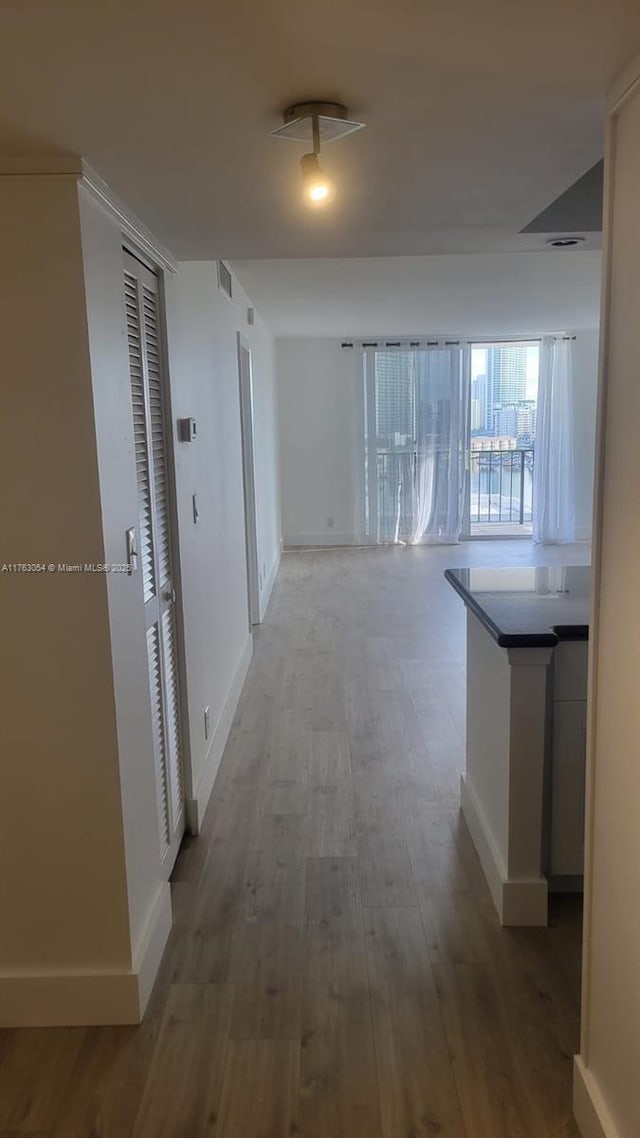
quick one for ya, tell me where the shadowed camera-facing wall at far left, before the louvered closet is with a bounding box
[0,176,134,1024]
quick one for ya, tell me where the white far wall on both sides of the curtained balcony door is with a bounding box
[276,329,598,545]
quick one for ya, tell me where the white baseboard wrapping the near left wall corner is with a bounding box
[0,882,171,1028]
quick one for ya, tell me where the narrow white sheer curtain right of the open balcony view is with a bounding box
[533,336,575,544]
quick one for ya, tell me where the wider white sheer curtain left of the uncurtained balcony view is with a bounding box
[367,341,469,545]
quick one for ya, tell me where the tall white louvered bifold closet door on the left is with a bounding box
[124,246,184,874]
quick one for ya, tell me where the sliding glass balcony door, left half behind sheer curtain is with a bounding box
[364,340,540,544]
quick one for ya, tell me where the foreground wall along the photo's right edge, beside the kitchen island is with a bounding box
[575,61,640,1138]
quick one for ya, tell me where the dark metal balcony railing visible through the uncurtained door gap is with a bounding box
[469,447,534,528]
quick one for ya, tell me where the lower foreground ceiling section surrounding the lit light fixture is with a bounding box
[0,0,640,259]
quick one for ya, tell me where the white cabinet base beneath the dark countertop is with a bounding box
[460,611,586,925]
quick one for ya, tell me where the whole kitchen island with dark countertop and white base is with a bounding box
[445,566,591,925]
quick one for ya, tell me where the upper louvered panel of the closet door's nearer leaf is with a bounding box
[124,272,156,602]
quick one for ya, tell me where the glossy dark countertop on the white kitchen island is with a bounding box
[444,566,591,648]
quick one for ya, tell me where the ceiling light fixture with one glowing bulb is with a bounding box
[271,102,366,207]
